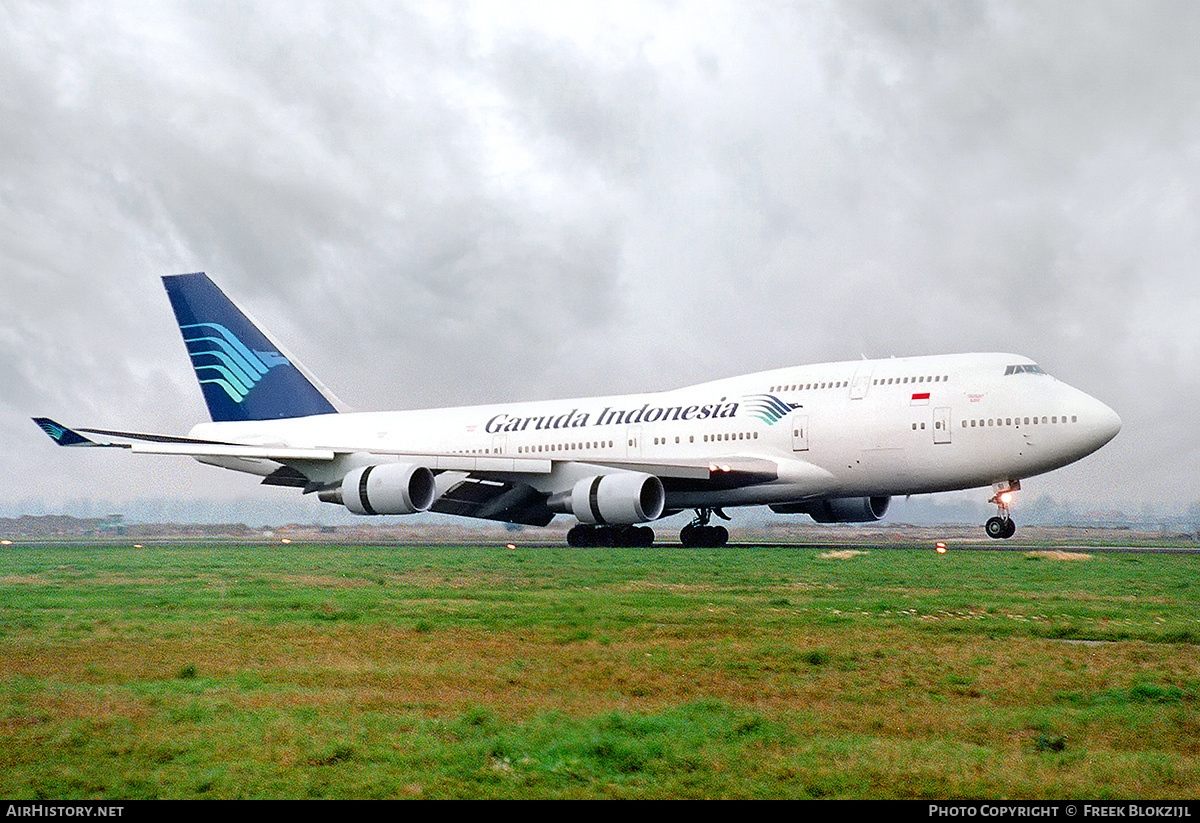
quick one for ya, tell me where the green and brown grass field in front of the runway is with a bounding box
[0,543,1200,799]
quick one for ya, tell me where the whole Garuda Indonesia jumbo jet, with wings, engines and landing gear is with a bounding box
[34,272,1121,547]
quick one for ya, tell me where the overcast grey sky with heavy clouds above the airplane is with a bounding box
[0,0,1200,525]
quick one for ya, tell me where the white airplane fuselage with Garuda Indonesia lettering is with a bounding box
[184,354,1121,518]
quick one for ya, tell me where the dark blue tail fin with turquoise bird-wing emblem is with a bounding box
[162,272,337,421]
